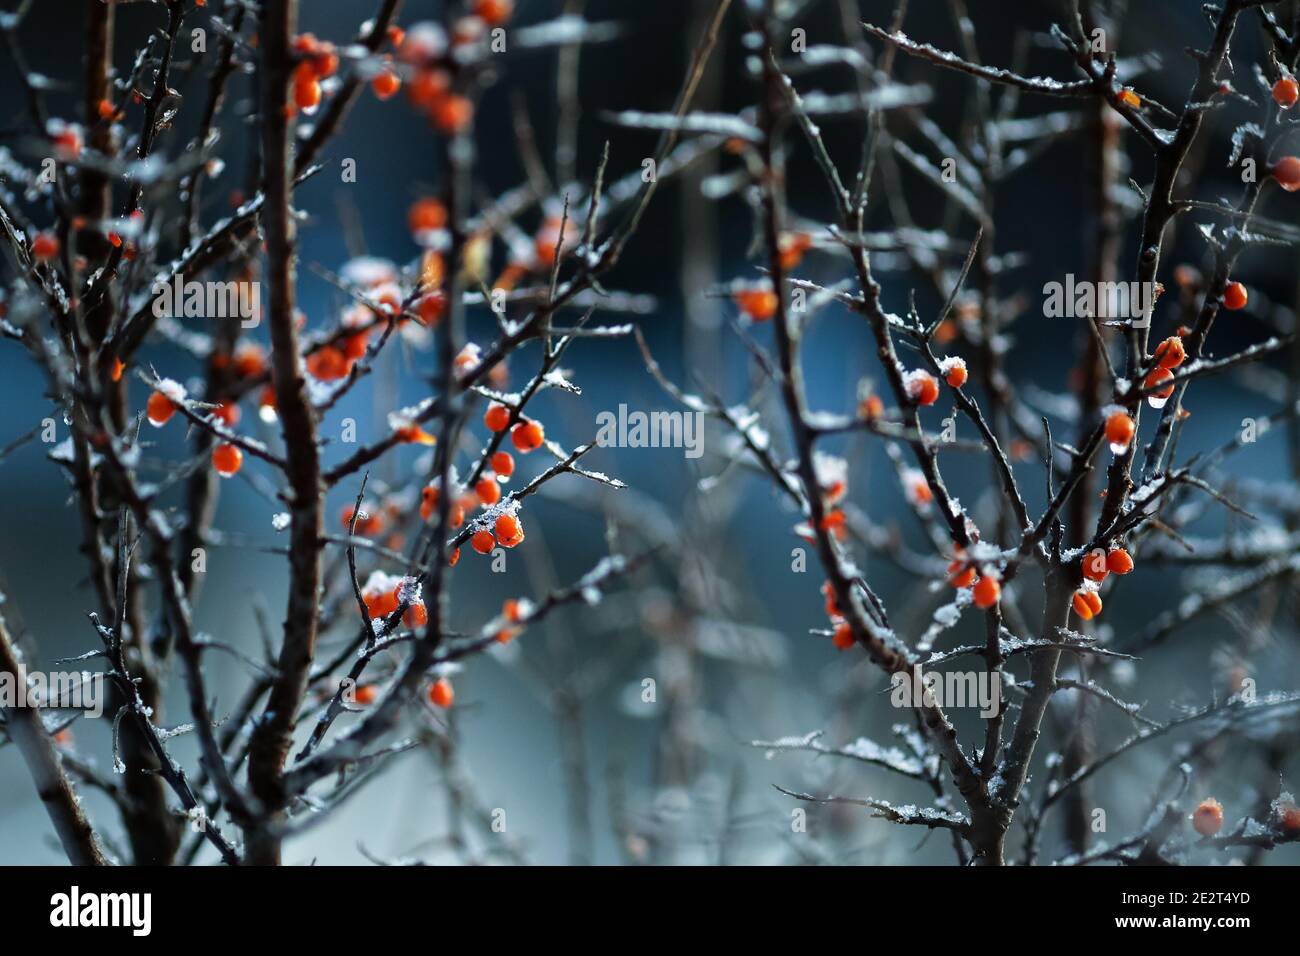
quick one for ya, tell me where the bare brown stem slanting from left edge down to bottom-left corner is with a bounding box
[0,606,109,866]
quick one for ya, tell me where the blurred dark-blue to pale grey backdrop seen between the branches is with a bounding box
[0,0,1300,864]
